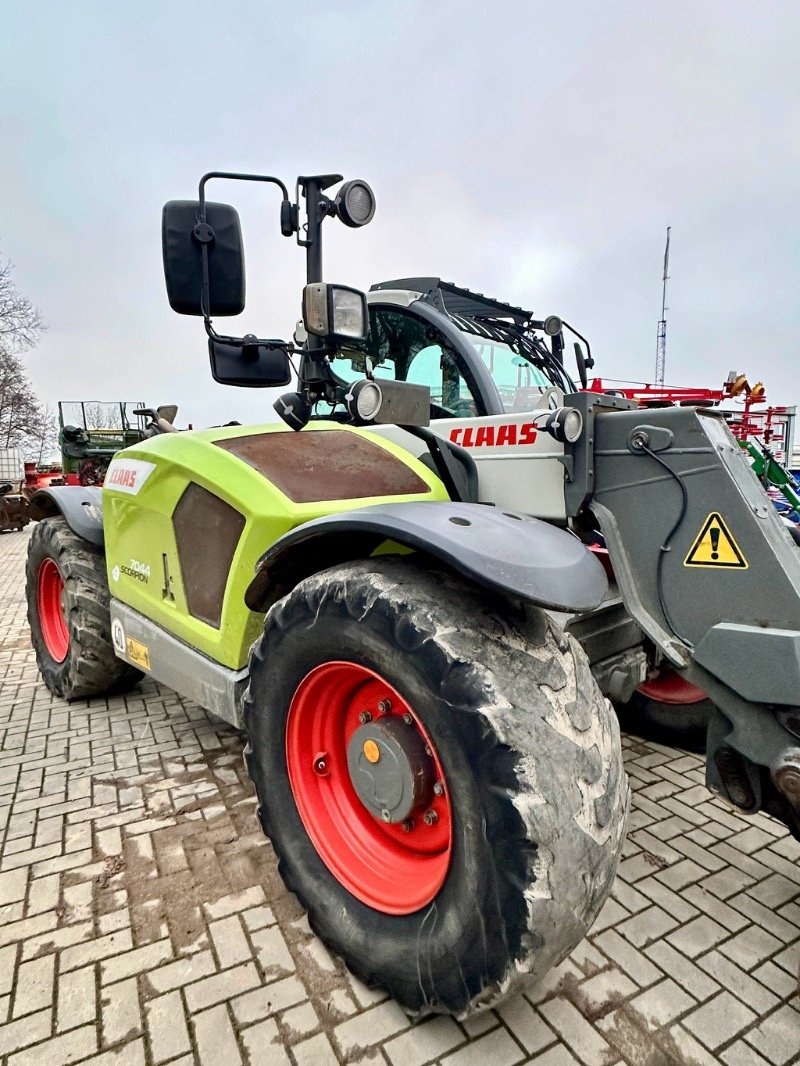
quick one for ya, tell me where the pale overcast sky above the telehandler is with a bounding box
[0,0,800,426]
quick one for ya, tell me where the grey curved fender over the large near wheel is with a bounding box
[244,501,608,612]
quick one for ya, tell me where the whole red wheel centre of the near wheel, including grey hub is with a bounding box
[286,661,452,915]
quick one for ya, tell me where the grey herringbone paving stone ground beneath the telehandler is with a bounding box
[0,526,800,1066]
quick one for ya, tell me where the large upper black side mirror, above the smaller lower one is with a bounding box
[161,200,244,317]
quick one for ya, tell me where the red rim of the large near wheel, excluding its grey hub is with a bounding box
[286,662,452,915]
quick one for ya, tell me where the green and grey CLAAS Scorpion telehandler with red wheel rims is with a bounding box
[27,173,800,1017]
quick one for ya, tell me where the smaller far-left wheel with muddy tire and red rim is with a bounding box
[26,517,142,699]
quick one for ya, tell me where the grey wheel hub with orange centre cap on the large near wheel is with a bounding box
[348,716,436,825]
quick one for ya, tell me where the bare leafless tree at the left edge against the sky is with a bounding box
[0,251,47,450]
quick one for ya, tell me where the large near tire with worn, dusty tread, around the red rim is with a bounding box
[244,559,628,1017]
